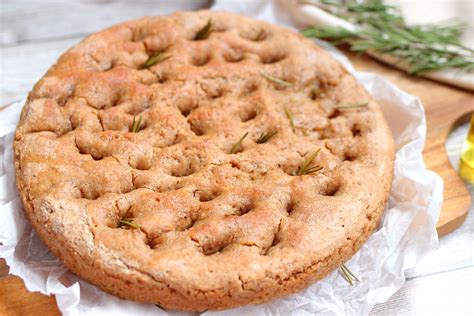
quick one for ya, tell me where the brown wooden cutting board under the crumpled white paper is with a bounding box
[0,51,474,315]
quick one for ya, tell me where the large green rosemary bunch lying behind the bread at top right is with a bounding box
[302,0,474,75]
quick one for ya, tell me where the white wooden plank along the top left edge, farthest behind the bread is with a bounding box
[0,0,211,45]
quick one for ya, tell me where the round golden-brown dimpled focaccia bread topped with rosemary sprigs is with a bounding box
[14,11,394,311]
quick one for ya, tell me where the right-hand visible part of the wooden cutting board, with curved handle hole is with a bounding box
[346,52,474,236]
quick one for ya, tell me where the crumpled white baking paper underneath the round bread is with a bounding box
[0,0,443,315]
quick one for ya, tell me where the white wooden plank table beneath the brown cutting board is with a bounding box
[0,0,474,315]
